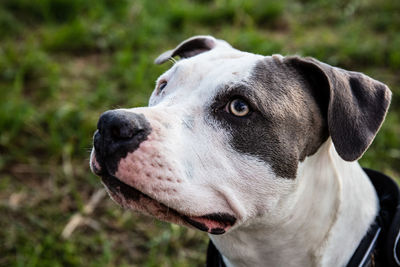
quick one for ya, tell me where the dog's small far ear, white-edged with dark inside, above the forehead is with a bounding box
[154,35,222,64]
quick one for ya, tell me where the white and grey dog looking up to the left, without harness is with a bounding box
[90,36,391,266]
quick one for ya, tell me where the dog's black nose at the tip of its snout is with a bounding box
[94,110,151,174]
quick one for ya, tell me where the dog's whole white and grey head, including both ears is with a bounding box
[90,36,390,234]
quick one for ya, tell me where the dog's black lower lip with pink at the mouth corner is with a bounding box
[101,174,236,235]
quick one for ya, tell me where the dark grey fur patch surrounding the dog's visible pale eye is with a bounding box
[212,57,328,178]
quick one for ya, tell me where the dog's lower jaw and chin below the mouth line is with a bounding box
[101,174,236,235]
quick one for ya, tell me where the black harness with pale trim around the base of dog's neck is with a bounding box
[206,169,400,267]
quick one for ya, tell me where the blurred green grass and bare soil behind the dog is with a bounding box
[0,0,400,266]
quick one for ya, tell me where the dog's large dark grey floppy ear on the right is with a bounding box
[286,57,391,161]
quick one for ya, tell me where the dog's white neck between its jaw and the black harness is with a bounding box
[210,139,378,266]
